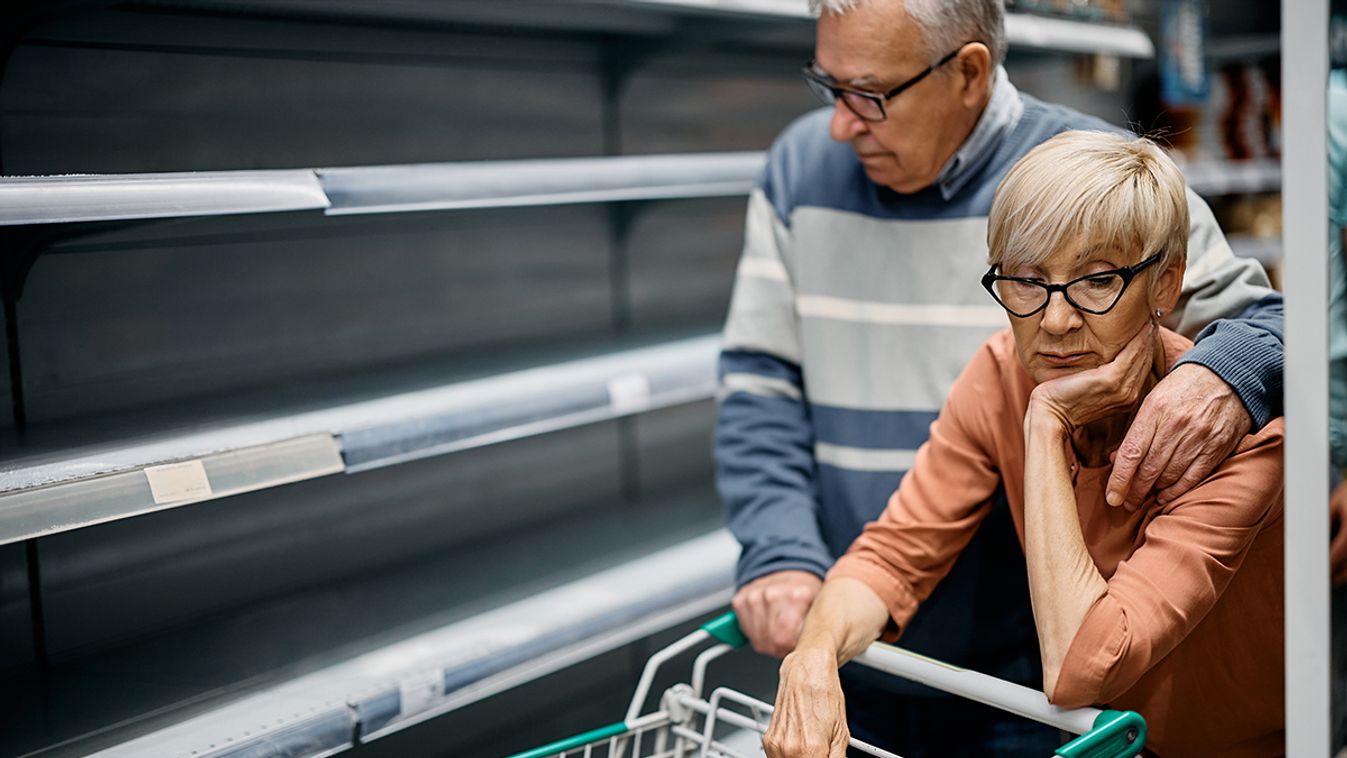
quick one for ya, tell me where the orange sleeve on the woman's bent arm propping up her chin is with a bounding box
[1052,419,1282,708]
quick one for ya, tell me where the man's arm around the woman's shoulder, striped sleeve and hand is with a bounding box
[1107,190,1285,508]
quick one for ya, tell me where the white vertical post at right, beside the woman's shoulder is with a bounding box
[1281,0,1329,758]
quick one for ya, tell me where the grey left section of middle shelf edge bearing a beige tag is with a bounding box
[0,435,343,545]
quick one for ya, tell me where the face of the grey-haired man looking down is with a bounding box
[815,0,979,193]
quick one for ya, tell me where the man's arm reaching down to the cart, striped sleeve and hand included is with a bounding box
[715,188,832,656]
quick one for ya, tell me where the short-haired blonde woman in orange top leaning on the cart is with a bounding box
[765,132,1284,758]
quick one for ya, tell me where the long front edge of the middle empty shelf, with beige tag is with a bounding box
[0,335,718,544]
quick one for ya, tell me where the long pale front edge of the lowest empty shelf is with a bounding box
[86,530,738,758]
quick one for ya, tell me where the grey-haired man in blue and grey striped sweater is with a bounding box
[715,0,1282,757]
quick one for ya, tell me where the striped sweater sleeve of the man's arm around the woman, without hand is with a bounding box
[1165,190,1285,431]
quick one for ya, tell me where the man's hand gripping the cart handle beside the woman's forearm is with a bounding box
[730,571,823,658]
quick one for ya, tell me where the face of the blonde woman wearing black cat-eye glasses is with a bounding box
[1001,248,1183,384]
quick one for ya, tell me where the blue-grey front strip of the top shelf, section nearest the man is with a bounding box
[318,152,766,215]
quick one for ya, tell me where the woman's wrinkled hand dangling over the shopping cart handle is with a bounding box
[762,649,850,758]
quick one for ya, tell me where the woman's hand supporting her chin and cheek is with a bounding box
[1024,322,1158,435]
